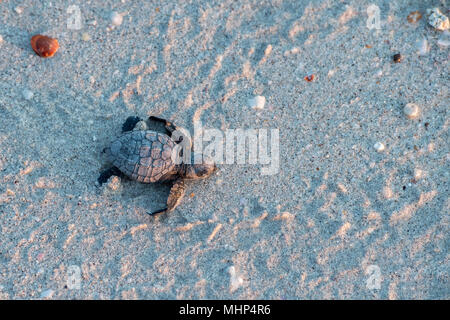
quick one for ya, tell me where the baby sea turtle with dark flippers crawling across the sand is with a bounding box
[98,116,217,215]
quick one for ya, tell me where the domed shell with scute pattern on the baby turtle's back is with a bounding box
[111,131,175,183]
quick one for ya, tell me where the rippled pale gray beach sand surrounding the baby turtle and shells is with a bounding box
[0,0,450,299]
